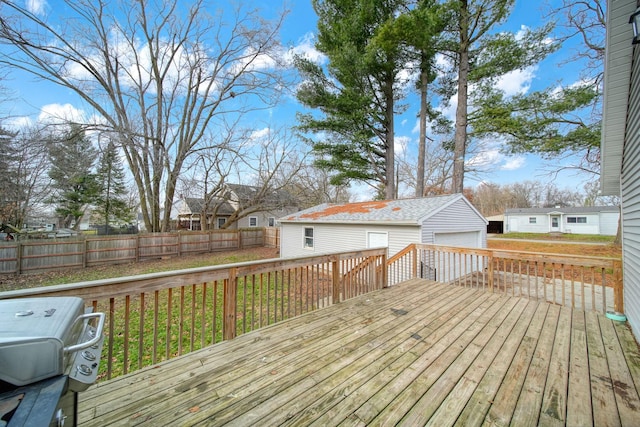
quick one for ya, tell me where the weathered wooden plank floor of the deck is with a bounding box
[79,280,640,426]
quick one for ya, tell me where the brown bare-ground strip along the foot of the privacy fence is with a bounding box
[0,248,279,292]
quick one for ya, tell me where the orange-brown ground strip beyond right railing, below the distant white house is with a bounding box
[487,239,622,258]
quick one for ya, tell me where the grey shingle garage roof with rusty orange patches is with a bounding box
[280,194,476,224]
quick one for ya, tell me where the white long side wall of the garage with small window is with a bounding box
[280,222,420,257]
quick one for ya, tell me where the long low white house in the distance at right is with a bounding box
[504,206,620,236]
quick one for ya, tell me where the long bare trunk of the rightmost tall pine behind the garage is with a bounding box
[451,0,469,193]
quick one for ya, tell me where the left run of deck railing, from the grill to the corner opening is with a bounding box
[0,249,387,379]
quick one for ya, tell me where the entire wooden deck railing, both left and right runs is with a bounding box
[0,244,624,379]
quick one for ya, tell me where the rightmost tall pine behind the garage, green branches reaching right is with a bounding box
[440,0,558,193]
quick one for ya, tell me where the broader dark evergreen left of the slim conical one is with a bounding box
[48,125,99,229]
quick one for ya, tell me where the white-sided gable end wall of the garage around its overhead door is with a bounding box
[421,200,487,248]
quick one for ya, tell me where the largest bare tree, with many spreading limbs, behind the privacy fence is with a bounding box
[0,0,285,231]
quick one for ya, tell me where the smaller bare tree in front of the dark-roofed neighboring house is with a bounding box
[181,127,306,230]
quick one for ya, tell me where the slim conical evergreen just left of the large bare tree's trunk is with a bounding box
[95,141,133,233]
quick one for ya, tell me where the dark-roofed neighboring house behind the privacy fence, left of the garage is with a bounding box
[178,184,298,230]
